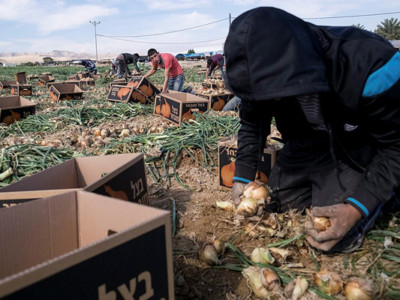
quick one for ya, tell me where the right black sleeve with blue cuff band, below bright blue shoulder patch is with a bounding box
[346,80,400,216]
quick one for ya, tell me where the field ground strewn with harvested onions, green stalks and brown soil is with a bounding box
[0,66,400,300]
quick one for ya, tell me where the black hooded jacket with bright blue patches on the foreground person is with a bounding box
[224,7,400,216]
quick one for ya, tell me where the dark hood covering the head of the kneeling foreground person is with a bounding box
[224,7,329,100]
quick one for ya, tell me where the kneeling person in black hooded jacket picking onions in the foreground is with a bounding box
[224,7,400,252]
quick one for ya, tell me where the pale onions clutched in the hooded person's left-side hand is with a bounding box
[236,181,269,217]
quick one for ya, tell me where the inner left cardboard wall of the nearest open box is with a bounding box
[0,193,78,281]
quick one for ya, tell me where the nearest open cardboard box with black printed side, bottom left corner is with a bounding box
[0,191,174,300]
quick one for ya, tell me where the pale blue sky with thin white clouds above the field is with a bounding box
[0,0,400,59]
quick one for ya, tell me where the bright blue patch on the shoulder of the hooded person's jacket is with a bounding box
[362,52,400,97]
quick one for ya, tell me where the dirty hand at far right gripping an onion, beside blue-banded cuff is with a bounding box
[305,203,362,251]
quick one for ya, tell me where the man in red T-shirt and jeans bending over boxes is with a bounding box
[144,48,185,92]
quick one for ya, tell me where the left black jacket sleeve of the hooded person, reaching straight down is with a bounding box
[233,99,272,182]
